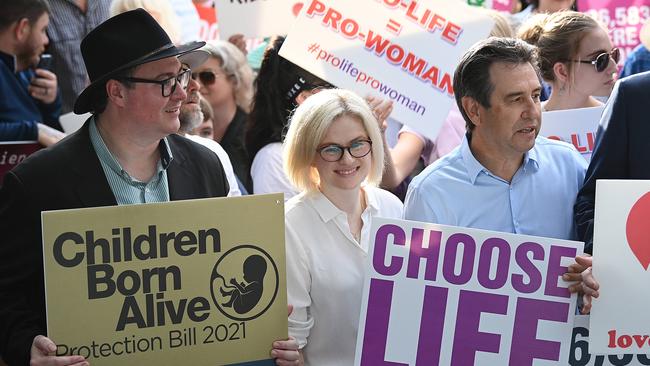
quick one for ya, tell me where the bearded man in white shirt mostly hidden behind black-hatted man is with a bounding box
[178,65,241,197]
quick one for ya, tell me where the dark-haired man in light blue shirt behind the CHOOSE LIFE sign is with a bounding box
[404,38,587,239]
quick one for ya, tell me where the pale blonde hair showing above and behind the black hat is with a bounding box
[110,0,181,44]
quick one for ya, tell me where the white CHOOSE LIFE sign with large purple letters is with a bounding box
[355,218,583,366]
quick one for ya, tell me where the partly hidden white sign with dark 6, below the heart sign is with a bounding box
[569,315,650,366]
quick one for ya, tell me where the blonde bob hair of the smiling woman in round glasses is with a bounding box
[283,89,384,192]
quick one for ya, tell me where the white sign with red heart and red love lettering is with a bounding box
[589,179,650,355]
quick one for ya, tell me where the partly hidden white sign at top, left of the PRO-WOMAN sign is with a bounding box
[216,0,307,38]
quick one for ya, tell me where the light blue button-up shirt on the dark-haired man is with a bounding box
[404,137,587,239]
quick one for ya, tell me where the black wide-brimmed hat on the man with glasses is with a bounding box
[74,9,205,114]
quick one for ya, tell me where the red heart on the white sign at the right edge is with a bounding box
[625,192,650,270]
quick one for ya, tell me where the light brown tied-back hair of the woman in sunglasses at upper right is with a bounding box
[518,11,604,82]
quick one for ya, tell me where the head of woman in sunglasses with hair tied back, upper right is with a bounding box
[519,11,620,111]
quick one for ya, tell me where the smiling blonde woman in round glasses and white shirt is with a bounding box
[283,89,402,366]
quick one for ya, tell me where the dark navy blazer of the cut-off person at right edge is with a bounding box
[575,72,650,253]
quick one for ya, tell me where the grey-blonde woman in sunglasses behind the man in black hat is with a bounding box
[192,41,253,192]
